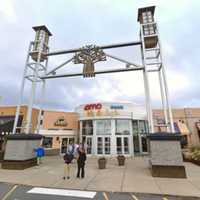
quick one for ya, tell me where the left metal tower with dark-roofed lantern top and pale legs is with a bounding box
[13,26,52,133]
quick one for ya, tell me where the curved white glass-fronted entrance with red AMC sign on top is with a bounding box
[77,103,148,156]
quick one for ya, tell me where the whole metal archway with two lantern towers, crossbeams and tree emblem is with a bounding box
[13,6,174,134]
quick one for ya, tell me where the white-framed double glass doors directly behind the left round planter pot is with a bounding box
[97,136,110,155]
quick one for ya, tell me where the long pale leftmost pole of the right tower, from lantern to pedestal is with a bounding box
[140,24,154,133]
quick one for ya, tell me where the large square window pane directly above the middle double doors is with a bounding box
[96,119,111,135]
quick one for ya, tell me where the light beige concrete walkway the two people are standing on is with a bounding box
[0,157,200,197]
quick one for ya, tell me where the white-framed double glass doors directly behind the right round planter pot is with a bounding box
[116,136,130,154]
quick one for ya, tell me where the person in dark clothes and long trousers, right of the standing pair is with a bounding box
[77,148,86,178]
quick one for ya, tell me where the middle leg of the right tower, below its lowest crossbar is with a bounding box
[158,71,169,132]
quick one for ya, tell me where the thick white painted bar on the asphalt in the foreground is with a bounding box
[27,187,96,199]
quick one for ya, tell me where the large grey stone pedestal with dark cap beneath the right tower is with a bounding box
[148,133,186,178]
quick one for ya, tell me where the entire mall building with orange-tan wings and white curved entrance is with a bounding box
[0,102,200,156]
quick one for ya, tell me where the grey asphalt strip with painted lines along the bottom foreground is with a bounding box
[0,183,200,200]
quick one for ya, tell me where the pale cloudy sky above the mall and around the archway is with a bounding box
[0,0,200,111]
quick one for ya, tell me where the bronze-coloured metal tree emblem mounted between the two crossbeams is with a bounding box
[74,45,106,77]
